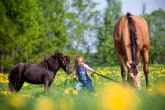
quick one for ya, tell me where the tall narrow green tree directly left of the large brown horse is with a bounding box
[97,0,121,65]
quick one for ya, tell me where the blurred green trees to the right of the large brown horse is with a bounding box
[144,9,165,64]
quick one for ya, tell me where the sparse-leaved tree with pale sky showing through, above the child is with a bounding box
[67,0,98,53]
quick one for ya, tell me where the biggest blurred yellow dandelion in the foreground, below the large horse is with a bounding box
[100,84,139,110]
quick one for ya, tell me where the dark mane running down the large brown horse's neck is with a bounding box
[126,13,138,74]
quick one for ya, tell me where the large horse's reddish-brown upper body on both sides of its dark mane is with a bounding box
[114,15,149,53]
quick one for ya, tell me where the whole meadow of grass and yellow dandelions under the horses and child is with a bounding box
[0,65,165,110]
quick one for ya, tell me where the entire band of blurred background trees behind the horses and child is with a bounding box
[0,0,165,71]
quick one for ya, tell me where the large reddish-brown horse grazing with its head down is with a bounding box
[114,13,150,89]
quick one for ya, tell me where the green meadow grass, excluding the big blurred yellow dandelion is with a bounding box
[0,64,165,110]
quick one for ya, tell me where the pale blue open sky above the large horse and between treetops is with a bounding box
[94,0,165,15]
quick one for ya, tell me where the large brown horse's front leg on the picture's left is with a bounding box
[117,52,126,82]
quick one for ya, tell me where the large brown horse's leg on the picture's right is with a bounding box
[142,48,149,88]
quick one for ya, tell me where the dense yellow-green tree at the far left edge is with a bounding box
[0,0,43,69]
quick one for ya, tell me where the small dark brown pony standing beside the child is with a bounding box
[9,53,71,92]
